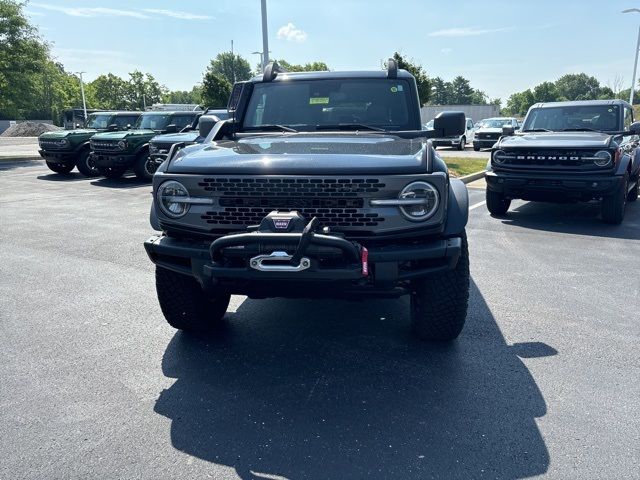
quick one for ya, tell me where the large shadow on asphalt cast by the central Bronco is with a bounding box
[155,284,557,479]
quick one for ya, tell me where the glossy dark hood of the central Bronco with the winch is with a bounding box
[168,134,426,175]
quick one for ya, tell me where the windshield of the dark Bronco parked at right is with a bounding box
[523,105,621,132]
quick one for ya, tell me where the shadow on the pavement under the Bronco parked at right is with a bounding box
[500,201,640,240]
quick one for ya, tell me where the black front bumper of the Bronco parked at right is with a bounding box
[485,171,624,201]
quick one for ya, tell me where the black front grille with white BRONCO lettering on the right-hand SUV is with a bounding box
[492,150,603,171]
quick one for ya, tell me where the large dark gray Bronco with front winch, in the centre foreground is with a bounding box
[145,60,469,340]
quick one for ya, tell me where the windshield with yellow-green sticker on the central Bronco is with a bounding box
[244,79,411,131]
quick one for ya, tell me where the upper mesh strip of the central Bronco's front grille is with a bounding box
[198,178,385,197]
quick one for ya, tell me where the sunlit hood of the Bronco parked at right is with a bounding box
[498,132,611,148]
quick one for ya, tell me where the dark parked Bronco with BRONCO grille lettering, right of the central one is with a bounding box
[486,100,640,224]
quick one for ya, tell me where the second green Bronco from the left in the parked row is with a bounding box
[91,111,202,180]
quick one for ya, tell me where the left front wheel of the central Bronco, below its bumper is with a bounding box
[156,267,230,331]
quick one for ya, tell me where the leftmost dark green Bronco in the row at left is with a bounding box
[38,112,140,177]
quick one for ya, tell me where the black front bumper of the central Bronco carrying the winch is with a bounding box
[144,233,462,297]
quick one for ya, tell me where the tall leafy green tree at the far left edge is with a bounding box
[0,0,49,118]
